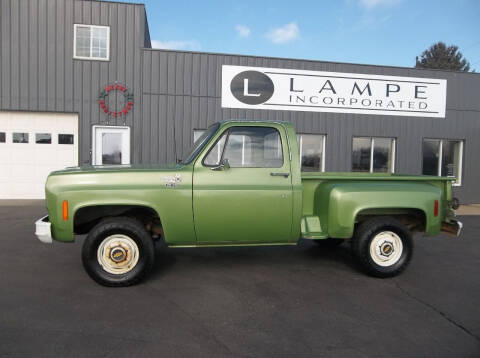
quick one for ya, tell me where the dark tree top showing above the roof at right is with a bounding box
[415,42,470,72]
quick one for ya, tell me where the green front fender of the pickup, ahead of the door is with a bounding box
[46,170,196,244]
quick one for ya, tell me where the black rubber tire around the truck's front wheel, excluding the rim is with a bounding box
[82,217,155,287]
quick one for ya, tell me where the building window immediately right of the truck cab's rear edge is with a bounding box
[297,134,325,172]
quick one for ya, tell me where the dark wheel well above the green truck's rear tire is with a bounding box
[355,209,427,232]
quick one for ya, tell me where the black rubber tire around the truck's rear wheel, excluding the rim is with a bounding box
[352,217,413,278]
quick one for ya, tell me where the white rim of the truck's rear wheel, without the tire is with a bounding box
[370,231,403,267]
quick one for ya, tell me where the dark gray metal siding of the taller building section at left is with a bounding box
[0,0,150,163]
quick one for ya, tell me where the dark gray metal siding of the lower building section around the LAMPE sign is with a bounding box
[142,49,480,202]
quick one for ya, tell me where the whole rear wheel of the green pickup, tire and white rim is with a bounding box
[352,217,413,277]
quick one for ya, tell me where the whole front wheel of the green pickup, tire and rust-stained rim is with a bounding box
[82,217,155,286]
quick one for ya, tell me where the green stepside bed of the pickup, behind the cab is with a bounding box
[301,172,454,239]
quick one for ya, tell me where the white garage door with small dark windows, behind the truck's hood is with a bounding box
[0,111,78,199]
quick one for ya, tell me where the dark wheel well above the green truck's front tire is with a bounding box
[73,205,161,235]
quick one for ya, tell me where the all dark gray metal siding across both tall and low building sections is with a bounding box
[0,0,480,202]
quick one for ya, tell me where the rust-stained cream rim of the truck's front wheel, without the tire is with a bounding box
[97,234,139,275]
